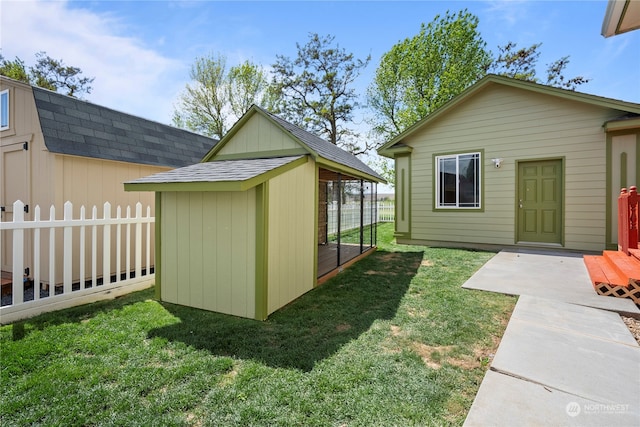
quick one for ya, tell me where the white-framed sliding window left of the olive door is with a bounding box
[435,153,481,209]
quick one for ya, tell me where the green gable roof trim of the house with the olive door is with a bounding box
[378,75,640,157]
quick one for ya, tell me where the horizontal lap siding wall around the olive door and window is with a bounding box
[403,85,620,250]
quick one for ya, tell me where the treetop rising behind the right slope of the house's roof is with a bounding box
[491,42,589,90]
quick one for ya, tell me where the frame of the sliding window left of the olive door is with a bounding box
[433,150,484,212]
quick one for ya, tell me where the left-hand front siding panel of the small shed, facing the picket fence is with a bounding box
[161,189,256,318]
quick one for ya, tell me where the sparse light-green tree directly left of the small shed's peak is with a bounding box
[173,54,268,138]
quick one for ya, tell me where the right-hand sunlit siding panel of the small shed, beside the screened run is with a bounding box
[267,162,317,313]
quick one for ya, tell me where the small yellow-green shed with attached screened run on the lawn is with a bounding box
[125,106,384,320]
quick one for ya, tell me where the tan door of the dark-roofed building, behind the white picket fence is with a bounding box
[0,143,31,271]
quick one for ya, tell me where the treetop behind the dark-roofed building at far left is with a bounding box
[0,52,95,97]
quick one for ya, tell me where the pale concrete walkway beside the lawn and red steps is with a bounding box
[463,251,640,426]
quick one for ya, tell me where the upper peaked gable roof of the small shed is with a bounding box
[202,105,385,182]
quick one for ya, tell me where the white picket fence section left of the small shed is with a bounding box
[0,200,155,324]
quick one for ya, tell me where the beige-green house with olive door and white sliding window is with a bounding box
[378,75,640,251]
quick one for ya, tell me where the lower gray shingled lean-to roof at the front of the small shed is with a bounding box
[126,156,303,184]
